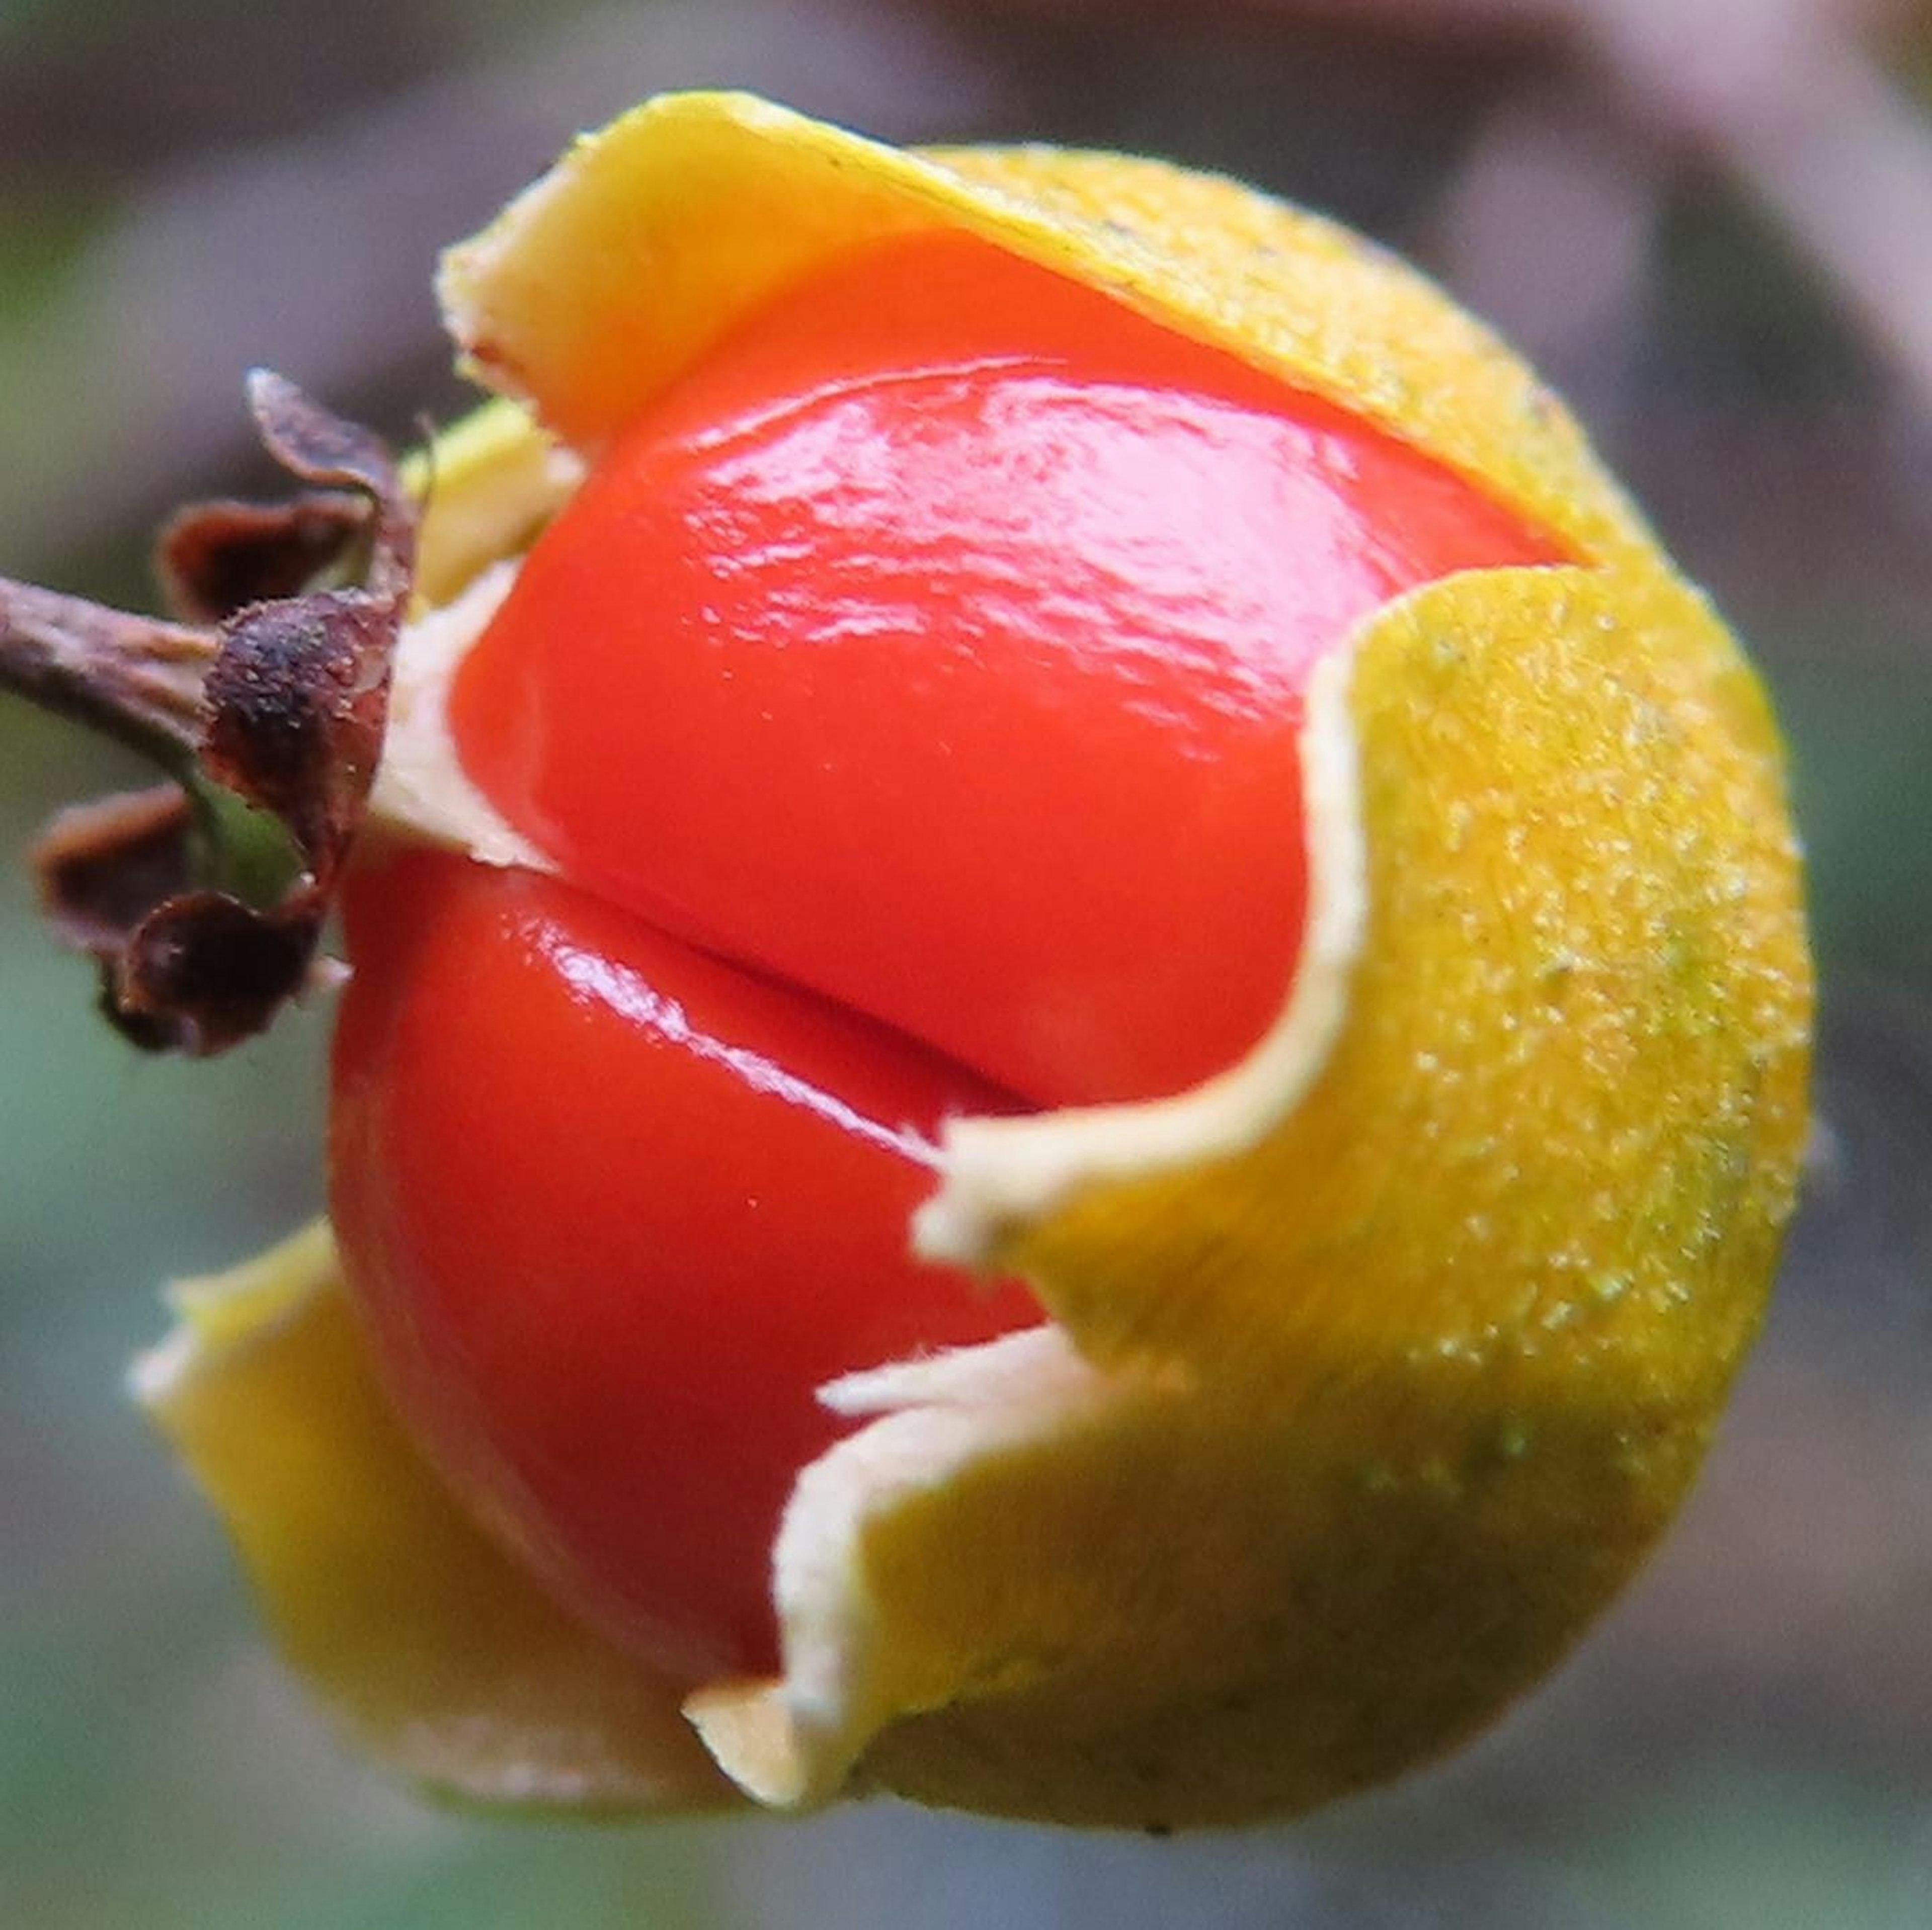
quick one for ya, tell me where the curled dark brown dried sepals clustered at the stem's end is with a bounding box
[0,371,416,1055]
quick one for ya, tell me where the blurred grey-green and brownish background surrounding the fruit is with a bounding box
[0,0,1932,1930]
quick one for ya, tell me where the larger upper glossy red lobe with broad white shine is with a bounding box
[454,236,1553,1103]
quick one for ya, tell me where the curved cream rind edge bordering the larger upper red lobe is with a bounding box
[912,649,1387,1268]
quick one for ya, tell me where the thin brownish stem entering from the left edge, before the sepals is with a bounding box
[0,577,220,779]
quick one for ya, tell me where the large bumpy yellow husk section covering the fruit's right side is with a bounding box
[838,572,1806,1824]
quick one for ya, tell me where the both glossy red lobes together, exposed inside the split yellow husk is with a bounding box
[334,222,1557,1681]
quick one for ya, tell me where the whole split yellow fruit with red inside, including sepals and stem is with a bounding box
[0,95,1810,1829]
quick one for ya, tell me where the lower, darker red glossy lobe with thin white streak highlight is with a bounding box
[331,852,1039,1681]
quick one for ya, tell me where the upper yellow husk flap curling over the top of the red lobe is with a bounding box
[441,95,1658,566]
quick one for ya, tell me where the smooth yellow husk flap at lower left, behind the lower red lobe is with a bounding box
[137,1223,732,1808]
